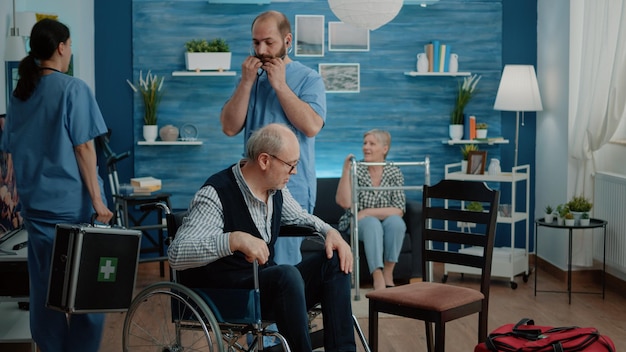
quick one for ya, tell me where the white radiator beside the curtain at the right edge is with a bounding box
[592,172,626,276]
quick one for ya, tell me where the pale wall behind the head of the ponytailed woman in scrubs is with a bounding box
[0,0,95,113]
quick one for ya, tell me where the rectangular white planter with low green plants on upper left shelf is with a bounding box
[185,38,232,71]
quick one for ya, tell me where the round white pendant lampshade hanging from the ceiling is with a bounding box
[328,0,403,30]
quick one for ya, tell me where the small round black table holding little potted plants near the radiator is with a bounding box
[535,218,607,304]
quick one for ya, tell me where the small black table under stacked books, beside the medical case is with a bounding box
[113,193,171,277]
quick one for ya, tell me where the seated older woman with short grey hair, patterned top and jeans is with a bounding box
[335,129,406,290]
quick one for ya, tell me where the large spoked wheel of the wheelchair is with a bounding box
[122,282,225,352]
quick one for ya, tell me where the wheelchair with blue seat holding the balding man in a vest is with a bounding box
[122,203,370,352]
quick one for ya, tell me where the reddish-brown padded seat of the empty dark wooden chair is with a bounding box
[365,282,485,312]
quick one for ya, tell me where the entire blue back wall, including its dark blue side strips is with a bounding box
[95,0,537,247]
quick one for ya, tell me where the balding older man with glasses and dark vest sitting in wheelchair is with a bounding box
[168,124,356,351]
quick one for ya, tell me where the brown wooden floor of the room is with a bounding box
[6,263,626,352]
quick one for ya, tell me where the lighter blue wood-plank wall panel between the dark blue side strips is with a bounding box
[128,0,502,208]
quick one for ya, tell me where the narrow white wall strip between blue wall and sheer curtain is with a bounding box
[535,0,570,269]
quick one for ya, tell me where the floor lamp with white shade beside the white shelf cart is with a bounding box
[493,65,543,167]
